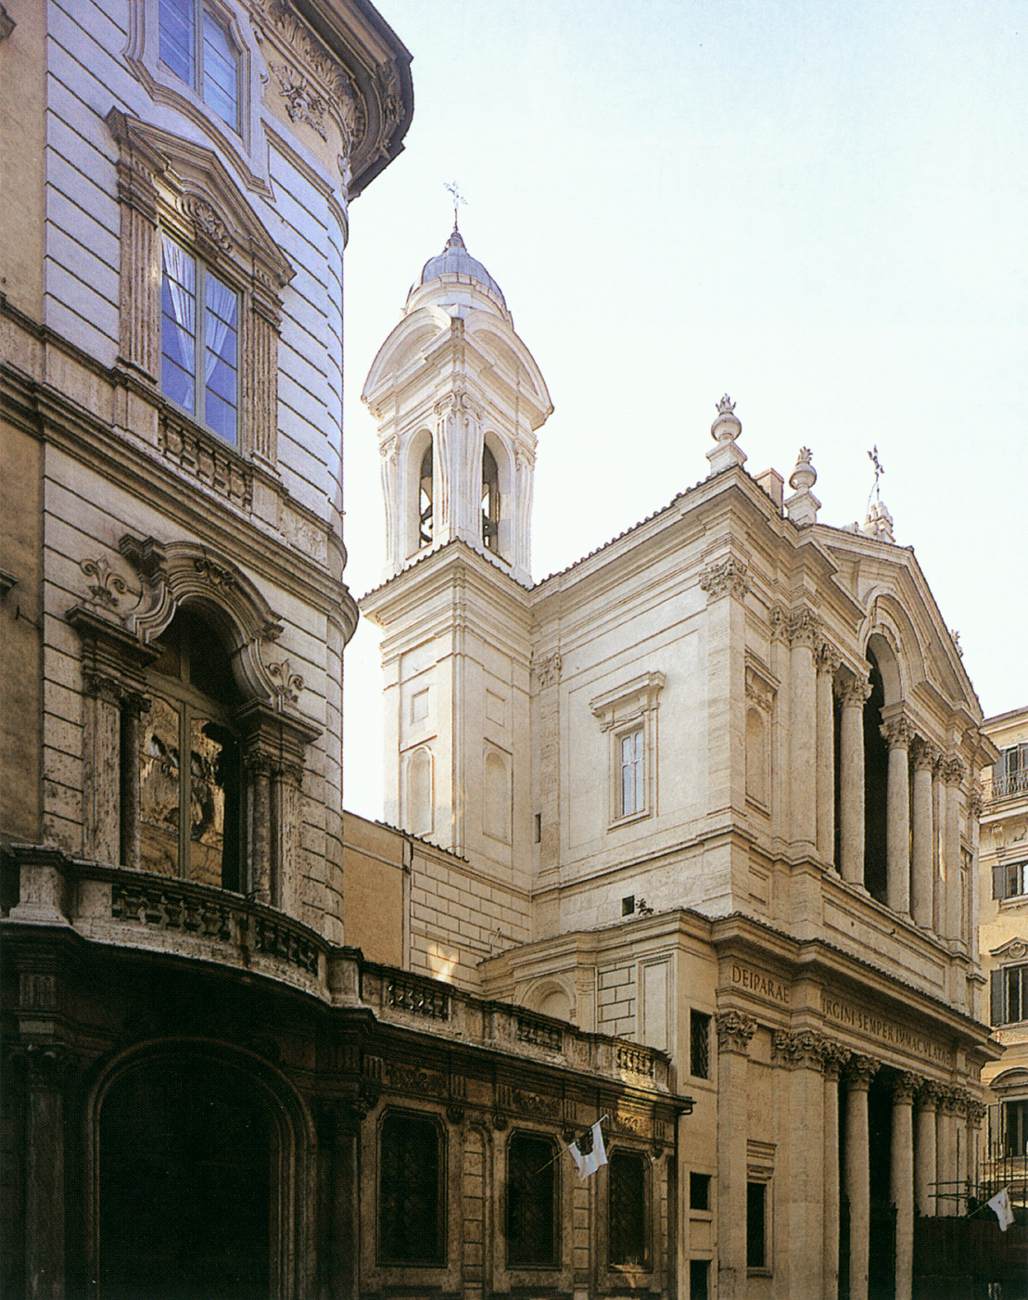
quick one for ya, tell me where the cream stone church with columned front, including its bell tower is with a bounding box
[361,228,996,1300]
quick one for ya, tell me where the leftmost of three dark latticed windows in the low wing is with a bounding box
[378,1112,446,1265]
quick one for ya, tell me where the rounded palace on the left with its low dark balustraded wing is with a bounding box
[0,0,689,1300]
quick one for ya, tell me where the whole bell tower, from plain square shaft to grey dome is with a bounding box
[361,222,552,868]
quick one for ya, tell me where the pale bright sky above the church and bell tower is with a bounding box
[344,0,1028,816]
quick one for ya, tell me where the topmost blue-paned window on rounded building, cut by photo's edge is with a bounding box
[159,0,239,131]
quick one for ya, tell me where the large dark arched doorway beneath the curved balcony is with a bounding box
[97,1056,277,1300]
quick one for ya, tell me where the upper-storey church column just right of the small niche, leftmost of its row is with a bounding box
[786,610,820,853]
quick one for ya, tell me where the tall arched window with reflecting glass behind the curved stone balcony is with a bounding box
[139,608,244,891]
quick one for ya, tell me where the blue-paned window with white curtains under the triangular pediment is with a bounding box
[161,235,239,447]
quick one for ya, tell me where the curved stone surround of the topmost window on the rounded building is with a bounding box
[125,0,272,189]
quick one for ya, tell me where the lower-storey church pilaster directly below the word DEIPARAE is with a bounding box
[716,1011,756,1300]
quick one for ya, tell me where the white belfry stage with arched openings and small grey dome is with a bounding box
[361,222,552,584]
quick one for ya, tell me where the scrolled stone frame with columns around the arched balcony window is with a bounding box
[66,534,321,910]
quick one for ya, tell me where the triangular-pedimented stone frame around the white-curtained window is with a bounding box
[107,109,294,488]
